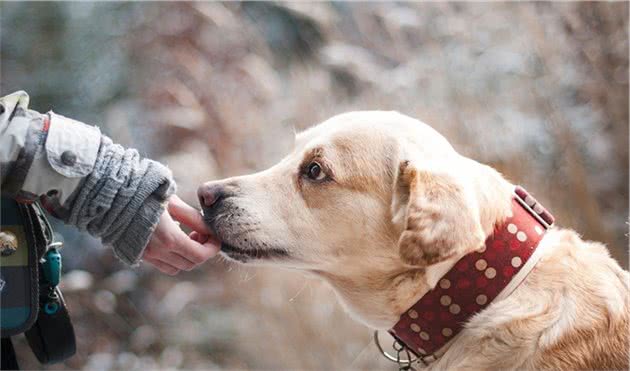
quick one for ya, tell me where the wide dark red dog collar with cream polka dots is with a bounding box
[389,186,554,362]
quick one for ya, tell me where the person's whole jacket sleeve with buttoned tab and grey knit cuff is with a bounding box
[0,92,218,269]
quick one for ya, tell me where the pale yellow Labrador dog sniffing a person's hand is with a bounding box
[198,111,630,370]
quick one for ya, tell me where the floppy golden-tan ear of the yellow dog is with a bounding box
[392,161,485,267]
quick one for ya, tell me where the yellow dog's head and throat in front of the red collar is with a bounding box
[198,111,509,327]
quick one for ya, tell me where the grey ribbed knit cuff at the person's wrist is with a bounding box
[61,136,175,265]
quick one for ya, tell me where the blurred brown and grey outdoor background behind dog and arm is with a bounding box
[0,2,628,370]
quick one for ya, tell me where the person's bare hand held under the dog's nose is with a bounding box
[143,195,221,276]
